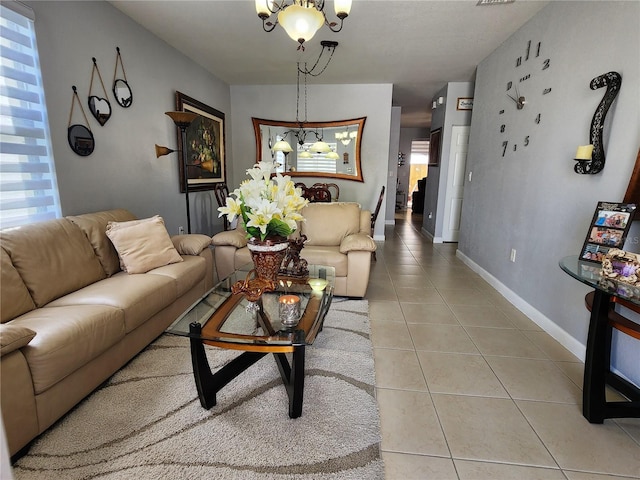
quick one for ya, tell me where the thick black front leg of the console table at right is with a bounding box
[582,290,611,423]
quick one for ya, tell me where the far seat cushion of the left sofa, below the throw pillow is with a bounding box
[48,272,177,333]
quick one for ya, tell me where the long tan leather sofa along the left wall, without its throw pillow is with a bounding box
[0,210,213,455]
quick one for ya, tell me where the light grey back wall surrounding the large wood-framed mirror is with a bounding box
[230,84,395,236]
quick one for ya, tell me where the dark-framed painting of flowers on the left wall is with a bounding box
[176,92,226,193]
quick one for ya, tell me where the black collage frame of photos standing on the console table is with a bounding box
[580,202,636,263]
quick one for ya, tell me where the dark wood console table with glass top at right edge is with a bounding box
[560,255,640,423]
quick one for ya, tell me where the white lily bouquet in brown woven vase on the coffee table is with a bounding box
[218,162,308,291]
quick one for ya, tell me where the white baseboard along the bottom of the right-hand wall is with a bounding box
[456,249,586,362]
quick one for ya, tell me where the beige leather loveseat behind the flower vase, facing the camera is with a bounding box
[212,202,376,297]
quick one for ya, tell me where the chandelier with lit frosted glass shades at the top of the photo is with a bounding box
[255,0,351,50]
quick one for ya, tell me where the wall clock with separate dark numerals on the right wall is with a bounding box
[498,40,551,157]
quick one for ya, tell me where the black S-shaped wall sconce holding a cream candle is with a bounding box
[573,72,622,175]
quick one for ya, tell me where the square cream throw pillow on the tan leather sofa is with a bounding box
[107,215,182,274]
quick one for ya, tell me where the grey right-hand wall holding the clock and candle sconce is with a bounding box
[458,1,640,383]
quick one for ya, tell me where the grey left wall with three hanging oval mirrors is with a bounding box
[27,1,233,234]
